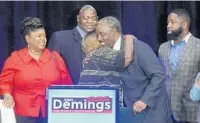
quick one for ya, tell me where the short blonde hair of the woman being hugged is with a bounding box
[82,32,101,54]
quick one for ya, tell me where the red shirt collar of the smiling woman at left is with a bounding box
[18,47,52,64]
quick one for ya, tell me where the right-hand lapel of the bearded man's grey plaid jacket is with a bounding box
[174,35,196,76]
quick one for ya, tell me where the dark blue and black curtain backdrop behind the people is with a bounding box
[0,1,200,70]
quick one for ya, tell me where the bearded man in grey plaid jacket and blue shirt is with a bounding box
[159,9,200,123]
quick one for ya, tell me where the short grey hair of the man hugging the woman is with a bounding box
[99,16,122,33]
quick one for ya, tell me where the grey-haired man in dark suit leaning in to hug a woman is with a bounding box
[96,16,172,123]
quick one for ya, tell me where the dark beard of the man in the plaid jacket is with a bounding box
[167,27,183,40]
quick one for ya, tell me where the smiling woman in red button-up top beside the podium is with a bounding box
[0,17,72,123]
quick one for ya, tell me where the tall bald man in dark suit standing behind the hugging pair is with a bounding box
[48,5,97,84]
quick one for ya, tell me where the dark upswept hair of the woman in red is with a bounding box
[20,17,44,37]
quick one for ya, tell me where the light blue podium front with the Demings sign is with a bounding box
[47,86,119,123]
